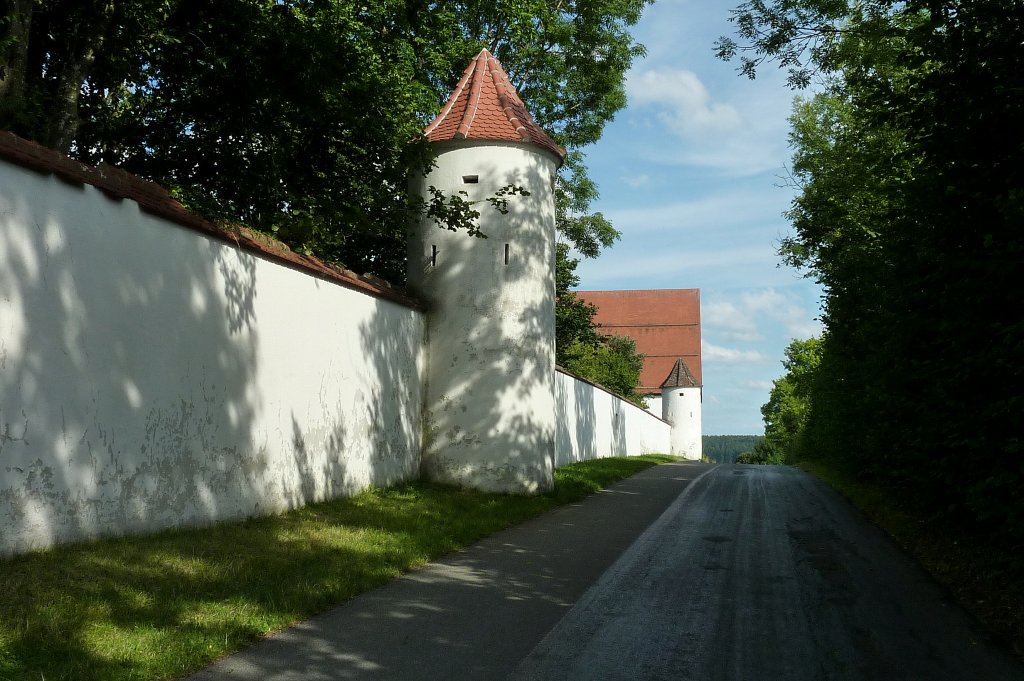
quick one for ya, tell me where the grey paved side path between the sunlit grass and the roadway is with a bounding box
[190,456,710,681]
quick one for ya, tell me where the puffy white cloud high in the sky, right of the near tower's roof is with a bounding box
[626,69,742,138]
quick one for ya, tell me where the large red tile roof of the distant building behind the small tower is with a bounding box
[575,289,701,394]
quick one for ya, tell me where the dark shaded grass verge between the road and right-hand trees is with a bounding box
[796,461,1024,658]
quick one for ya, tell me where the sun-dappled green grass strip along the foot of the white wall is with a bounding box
[0,456,673,681]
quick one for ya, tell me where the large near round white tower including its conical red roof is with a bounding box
[409,50,565,494]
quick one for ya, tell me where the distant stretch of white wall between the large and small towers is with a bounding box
[555,371,672,466]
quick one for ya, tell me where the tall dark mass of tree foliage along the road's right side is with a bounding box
[720,0,1024,543]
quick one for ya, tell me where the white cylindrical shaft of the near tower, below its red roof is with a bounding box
[410,146,555,493]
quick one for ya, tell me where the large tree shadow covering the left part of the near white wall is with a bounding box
[0,165,262,553]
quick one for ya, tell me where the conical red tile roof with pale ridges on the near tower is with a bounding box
[423,49,565,160]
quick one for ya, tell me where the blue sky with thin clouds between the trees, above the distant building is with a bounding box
[578,0,820,435]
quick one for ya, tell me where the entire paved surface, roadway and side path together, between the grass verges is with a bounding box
[191,464,1024,681]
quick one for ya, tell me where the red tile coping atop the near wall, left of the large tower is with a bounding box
[0,130,426,311]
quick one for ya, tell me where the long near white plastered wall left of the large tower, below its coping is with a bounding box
[0,162,425,554]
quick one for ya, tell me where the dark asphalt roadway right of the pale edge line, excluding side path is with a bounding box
[510,466,1024,681]
